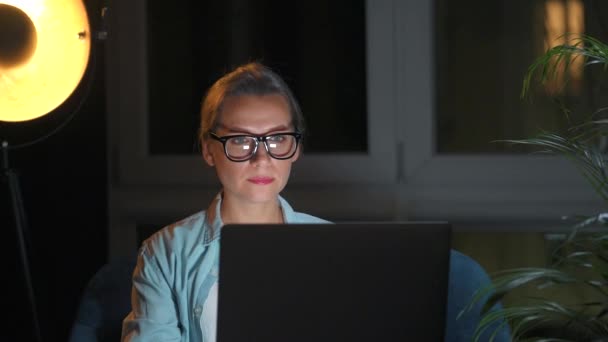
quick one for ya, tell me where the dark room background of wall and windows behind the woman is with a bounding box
[0,0,608,341]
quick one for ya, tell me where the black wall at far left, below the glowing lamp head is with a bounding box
[0,1,108,341]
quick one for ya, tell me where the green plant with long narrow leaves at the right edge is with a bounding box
[463,35,608,341]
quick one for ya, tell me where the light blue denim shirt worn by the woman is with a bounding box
[122,195,329,342]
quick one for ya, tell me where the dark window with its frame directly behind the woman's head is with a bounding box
[110,0,397,186]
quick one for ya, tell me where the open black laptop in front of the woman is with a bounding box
[217,222,451,342]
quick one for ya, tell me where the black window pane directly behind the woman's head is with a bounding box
[147,0,368,154]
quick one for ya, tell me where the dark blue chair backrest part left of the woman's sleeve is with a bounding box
[70,257,136,342]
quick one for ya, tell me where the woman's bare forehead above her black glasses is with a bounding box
[218,94,292,133]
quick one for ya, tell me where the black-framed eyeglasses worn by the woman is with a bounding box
[209,132,302,162]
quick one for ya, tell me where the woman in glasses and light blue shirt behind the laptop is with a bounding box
[123,63,328,341]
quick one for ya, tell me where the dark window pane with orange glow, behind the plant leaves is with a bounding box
[435,0,605,154]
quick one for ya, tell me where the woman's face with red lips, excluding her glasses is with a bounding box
[203,94,300,203]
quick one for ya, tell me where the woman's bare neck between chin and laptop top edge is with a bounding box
[220,192,283,224]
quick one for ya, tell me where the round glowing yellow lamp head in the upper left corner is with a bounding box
[0,0,91,121]
